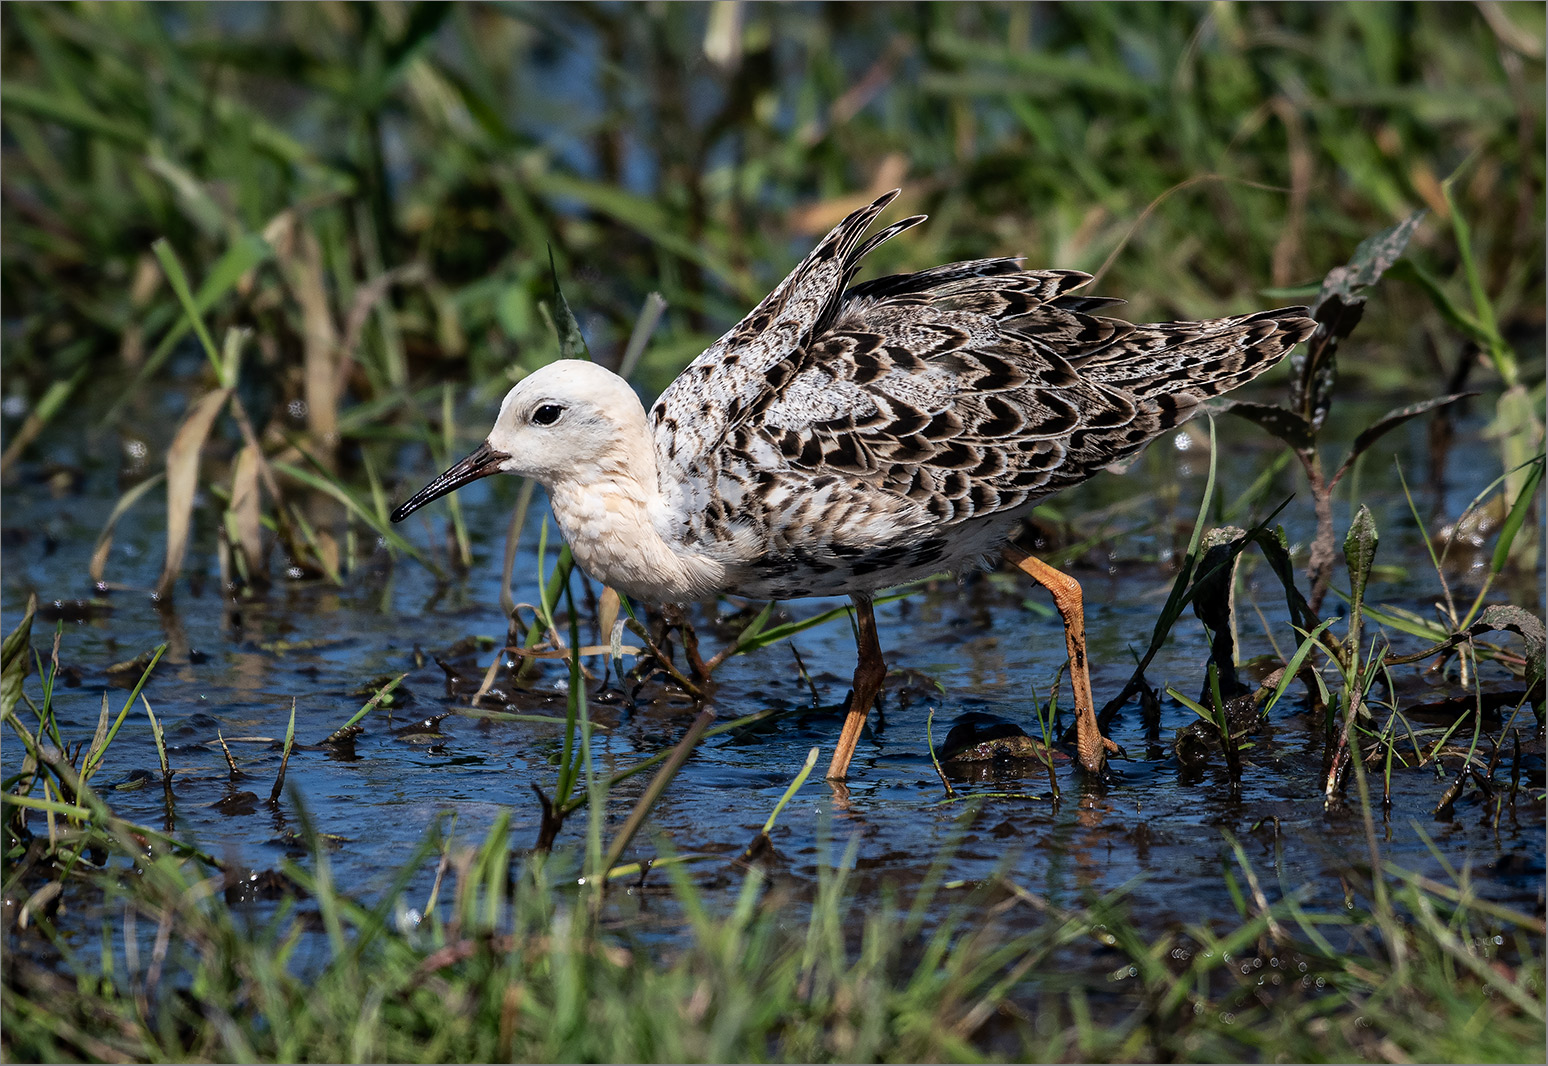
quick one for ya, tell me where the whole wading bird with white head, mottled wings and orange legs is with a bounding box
[392,190,1313,780]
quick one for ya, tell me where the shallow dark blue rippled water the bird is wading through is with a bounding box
[0,392,1545,965]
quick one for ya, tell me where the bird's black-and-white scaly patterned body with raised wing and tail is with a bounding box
[652,192,1314,599]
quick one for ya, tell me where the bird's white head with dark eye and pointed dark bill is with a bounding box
[392,359,655,521]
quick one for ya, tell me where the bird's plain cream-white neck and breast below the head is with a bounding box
[548,433,726,603]
